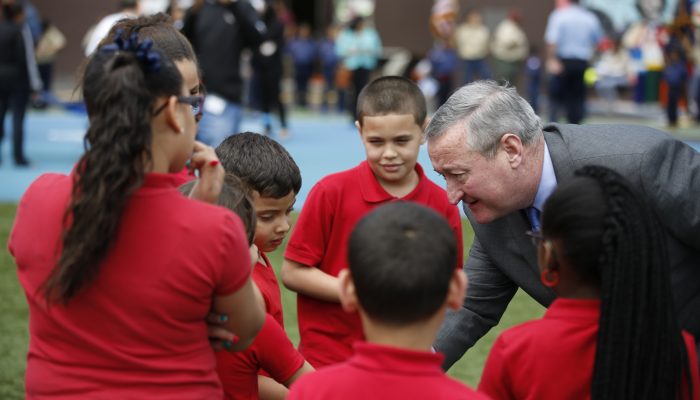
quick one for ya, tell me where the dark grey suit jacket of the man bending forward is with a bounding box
[435,124,700,367]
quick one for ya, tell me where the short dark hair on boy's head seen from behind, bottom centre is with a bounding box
[348,201,457,325]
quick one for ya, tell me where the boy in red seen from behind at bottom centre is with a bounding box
[288,202,488,400]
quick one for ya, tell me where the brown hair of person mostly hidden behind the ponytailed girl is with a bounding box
[100,13,197,62]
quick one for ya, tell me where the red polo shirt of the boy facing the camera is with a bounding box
[284,161,462,368]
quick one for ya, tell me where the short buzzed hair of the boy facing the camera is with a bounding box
[357,76,427,127]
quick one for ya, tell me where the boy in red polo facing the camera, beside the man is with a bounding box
[282,76,462,368]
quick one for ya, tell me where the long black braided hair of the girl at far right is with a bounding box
[542,166,697,399]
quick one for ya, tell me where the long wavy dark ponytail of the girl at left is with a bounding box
[43,39,183,303]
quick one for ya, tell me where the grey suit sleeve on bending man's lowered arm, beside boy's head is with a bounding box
[435,238,517,369]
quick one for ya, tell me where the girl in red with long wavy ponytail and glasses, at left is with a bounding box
[9,30,264,399]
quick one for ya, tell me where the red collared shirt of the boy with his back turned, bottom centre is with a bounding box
[287,342,488,400]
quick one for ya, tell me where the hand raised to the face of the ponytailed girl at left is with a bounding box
[190,141,225,204]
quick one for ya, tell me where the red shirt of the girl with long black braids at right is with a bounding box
[479,298,700,400]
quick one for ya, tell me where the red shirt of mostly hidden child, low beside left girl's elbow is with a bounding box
[216,314,304,400]
